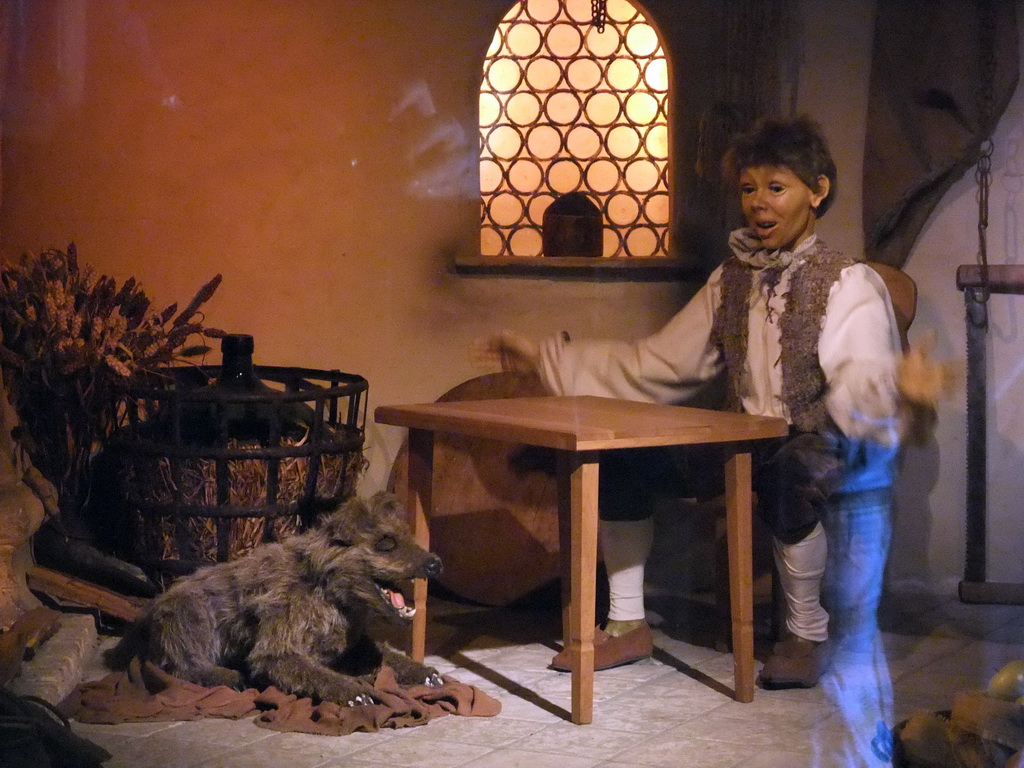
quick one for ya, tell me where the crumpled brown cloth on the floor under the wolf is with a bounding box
[60,659,502,736]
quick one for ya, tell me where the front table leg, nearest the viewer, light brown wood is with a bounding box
[558,451,598,724]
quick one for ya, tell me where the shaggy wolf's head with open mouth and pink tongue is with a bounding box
[287,493,441,622]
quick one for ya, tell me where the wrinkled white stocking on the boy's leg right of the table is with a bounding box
[773,522,828,642]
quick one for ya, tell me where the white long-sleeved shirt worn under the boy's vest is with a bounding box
[539,234,900,443]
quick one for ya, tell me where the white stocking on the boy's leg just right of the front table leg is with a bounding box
[599,517,654,622]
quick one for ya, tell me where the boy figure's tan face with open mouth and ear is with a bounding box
[739,165,828,251]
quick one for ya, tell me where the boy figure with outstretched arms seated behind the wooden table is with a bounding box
[481,118,901,688]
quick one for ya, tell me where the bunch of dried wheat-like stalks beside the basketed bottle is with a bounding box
[0,243,224,516]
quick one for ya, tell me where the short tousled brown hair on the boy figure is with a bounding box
[722,116,839,218]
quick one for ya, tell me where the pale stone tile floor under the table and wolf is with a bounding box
[58,597,1024,768]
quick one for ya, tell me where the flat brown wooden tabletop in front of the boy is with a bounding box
[374,395,788,451]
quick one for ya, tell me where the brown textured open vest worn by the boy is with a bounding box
[712,241,855,432]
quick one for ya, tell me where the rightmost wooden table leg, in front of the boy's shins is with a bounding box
[725,453,754,701]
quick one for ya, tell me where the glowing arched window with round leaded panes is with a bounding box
[480,0,670,258]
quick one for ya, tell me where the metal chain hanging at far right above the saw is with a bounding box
[974,0,995,301]
